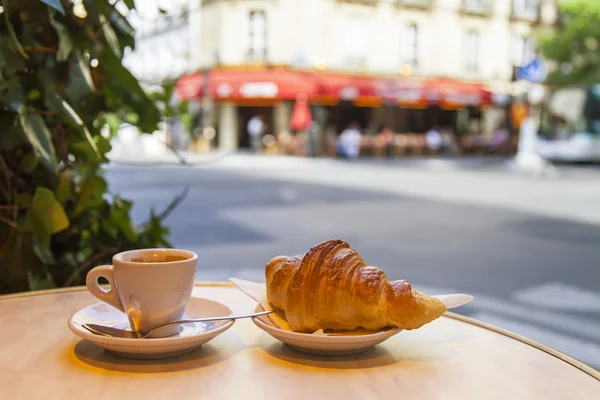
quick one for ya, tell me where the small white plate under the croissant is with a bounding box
[252,305,402,356]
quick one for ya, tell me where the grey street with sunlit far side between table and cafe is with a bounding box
[107,155,600,368]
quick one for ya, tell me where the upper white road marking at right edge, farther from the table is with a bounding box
[513,282,600,313]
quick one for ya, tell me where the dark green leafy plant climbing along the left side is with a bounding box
[0,0,183,293]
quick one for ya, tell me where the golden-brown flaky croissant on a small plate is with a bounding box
[265,240,446,332]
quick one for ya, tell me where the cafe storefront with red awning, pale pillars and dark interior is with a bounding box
[176,67,491,150]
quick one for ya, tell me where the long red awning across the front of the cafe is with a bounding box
[176,69,491,108]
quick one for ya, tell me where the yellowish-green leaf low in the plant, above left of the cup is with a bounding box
[23,186,69,246]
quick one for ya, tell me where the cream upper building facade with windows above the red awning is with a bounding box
[199,0,556,86]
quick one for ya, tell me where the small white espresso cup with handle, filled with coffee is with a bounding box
[86,249,198,335]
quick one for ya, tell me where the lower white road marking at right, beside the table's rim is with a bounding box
[472,312,600,368]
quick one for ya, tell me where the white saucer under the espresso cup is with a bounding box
[69,297,234,359]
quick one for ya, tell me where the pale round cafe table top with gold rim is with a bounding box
[0,284,600,400]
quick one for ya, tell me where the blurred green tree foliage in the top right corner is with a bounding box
[539,0,600,85]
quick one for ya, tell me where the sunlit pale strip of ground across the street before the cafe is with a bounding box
[203,155,600,224]
